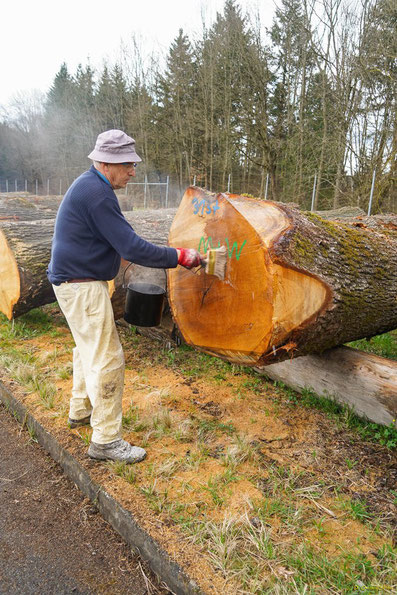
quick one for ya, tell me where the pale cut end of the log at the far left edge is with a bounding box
[0,231,20,320]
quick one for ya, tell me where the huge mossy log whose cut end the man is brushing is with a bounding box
[168,187,397,365]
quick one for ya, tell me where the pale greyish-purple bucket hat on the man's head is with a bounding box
[88,130,142,163]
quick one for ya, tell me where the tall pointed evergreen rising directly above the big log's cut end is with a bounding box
[198,0,267,190]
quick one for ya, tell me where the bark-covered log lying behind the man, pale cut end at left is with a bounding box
[0,209,175,319]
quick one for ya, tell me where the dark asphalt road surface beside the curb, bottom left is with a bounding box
[0,404,169,595]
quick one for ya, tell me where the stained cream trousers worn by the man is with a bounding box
[53,281,124,444]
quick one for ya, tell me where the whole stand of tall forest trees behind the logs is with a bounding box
[0,0,397,213]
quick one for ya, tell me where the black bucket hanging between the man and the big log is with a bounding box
[124,283,165,326]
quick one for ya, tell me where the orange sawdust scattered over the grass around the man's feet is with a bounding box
[1,306,397,593]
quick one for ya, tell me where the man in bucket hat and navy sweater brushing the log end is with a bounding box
[47,130,201,463]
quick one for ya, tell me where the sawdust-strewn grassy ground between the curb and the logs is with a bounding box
[0,306,397,594]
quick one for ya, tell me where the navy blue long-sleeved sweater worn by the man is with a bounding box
[47,166,178,285]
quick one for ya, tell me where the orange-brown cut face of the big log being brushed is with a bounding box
[168,187,327,365]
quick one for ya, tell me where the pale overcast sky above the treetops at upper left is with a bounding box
[0,0,274,105]
